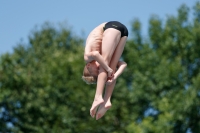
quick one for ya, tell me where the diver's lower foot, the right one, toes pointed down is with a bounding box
[96,103,112,120]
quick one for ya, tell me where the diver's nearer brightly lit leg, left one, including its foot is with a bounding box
[90,28,121,117]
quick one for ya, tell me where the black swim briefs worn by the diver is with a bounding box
[103,21,128,37]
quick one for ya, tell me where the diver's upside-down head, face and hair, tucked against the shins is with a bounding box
[82,61,99,84]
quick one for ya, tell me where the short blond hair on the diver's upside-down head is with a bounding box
[82,65,97,84]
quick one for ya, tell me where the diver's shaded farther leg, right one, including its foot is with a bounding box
[96,36,127,120]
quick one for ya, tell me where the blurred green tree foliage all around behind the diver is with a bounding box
[0,2,200,133]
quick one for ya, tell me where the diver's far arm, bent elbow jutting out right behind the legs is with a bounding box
[106,61,127,85]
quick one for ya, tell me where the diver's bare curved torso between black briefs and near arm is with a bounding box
[84,23,106,54]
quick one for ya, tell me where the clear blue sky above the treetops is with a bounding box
[0,0,197,54]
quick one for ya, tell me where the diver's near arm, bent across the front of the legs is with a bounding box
[84,51,114,77]
